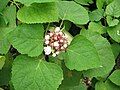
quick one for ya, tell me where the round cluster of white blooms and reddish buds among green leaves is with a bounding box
[44,27,68,57]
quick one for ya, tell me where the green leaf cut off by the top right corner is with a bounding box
[106,0,120,17]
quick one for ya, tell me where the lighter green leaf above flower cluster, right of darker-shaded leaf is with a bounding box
[58,1,89,24]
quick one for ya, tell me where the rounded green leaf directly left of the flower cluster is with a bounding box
[9,24,44,56]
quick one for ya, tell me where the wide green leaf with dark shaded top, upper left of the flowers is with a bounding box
[17,3,58,23]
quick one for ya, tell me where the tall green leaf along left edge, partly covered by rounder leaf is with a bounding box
[0,5,16,54]
